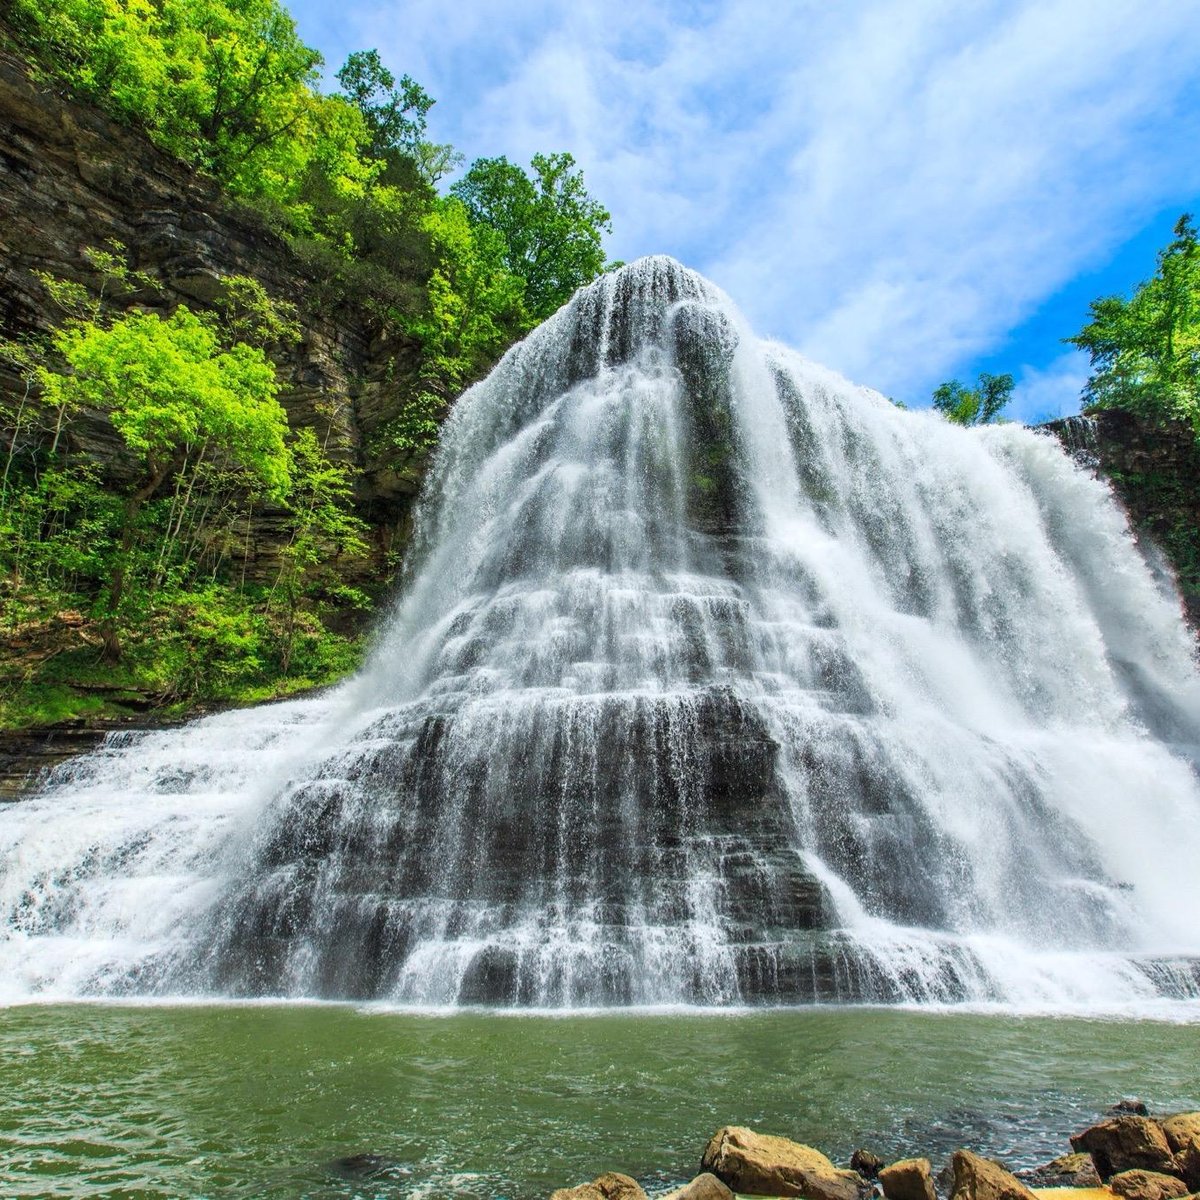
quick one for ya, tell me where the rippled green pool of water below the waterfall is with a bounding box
[0,1006,1200,1200]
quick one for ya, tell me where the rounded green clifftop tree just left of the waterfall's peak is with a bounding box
[451,154,612,320]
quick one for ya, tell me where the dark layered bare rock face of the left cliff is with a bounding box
[0,34,425,600]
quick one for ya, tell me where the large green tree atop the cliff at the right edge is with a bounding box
[1066,214,1200,436]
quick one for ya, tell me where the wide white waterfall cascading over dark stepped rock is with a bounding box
[0,258,1200,1007]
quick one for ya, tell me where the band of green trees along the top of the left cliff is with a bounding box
[10,0,610,384]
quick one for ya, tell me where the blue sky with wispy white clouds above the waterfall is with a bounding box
[289,0,1200,421]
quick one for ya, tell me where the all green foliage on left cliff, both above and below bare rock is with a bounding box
[0,0,608,726]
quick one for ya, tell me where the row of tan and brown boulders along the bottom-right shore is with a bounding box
[551,1100,1200,1200]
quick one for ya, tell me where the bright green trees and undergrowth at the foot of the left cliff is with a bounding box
[0,251,367,725]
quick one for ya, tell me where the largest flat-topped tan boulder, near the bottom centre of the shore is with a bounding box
[700,1126,863,1200]
